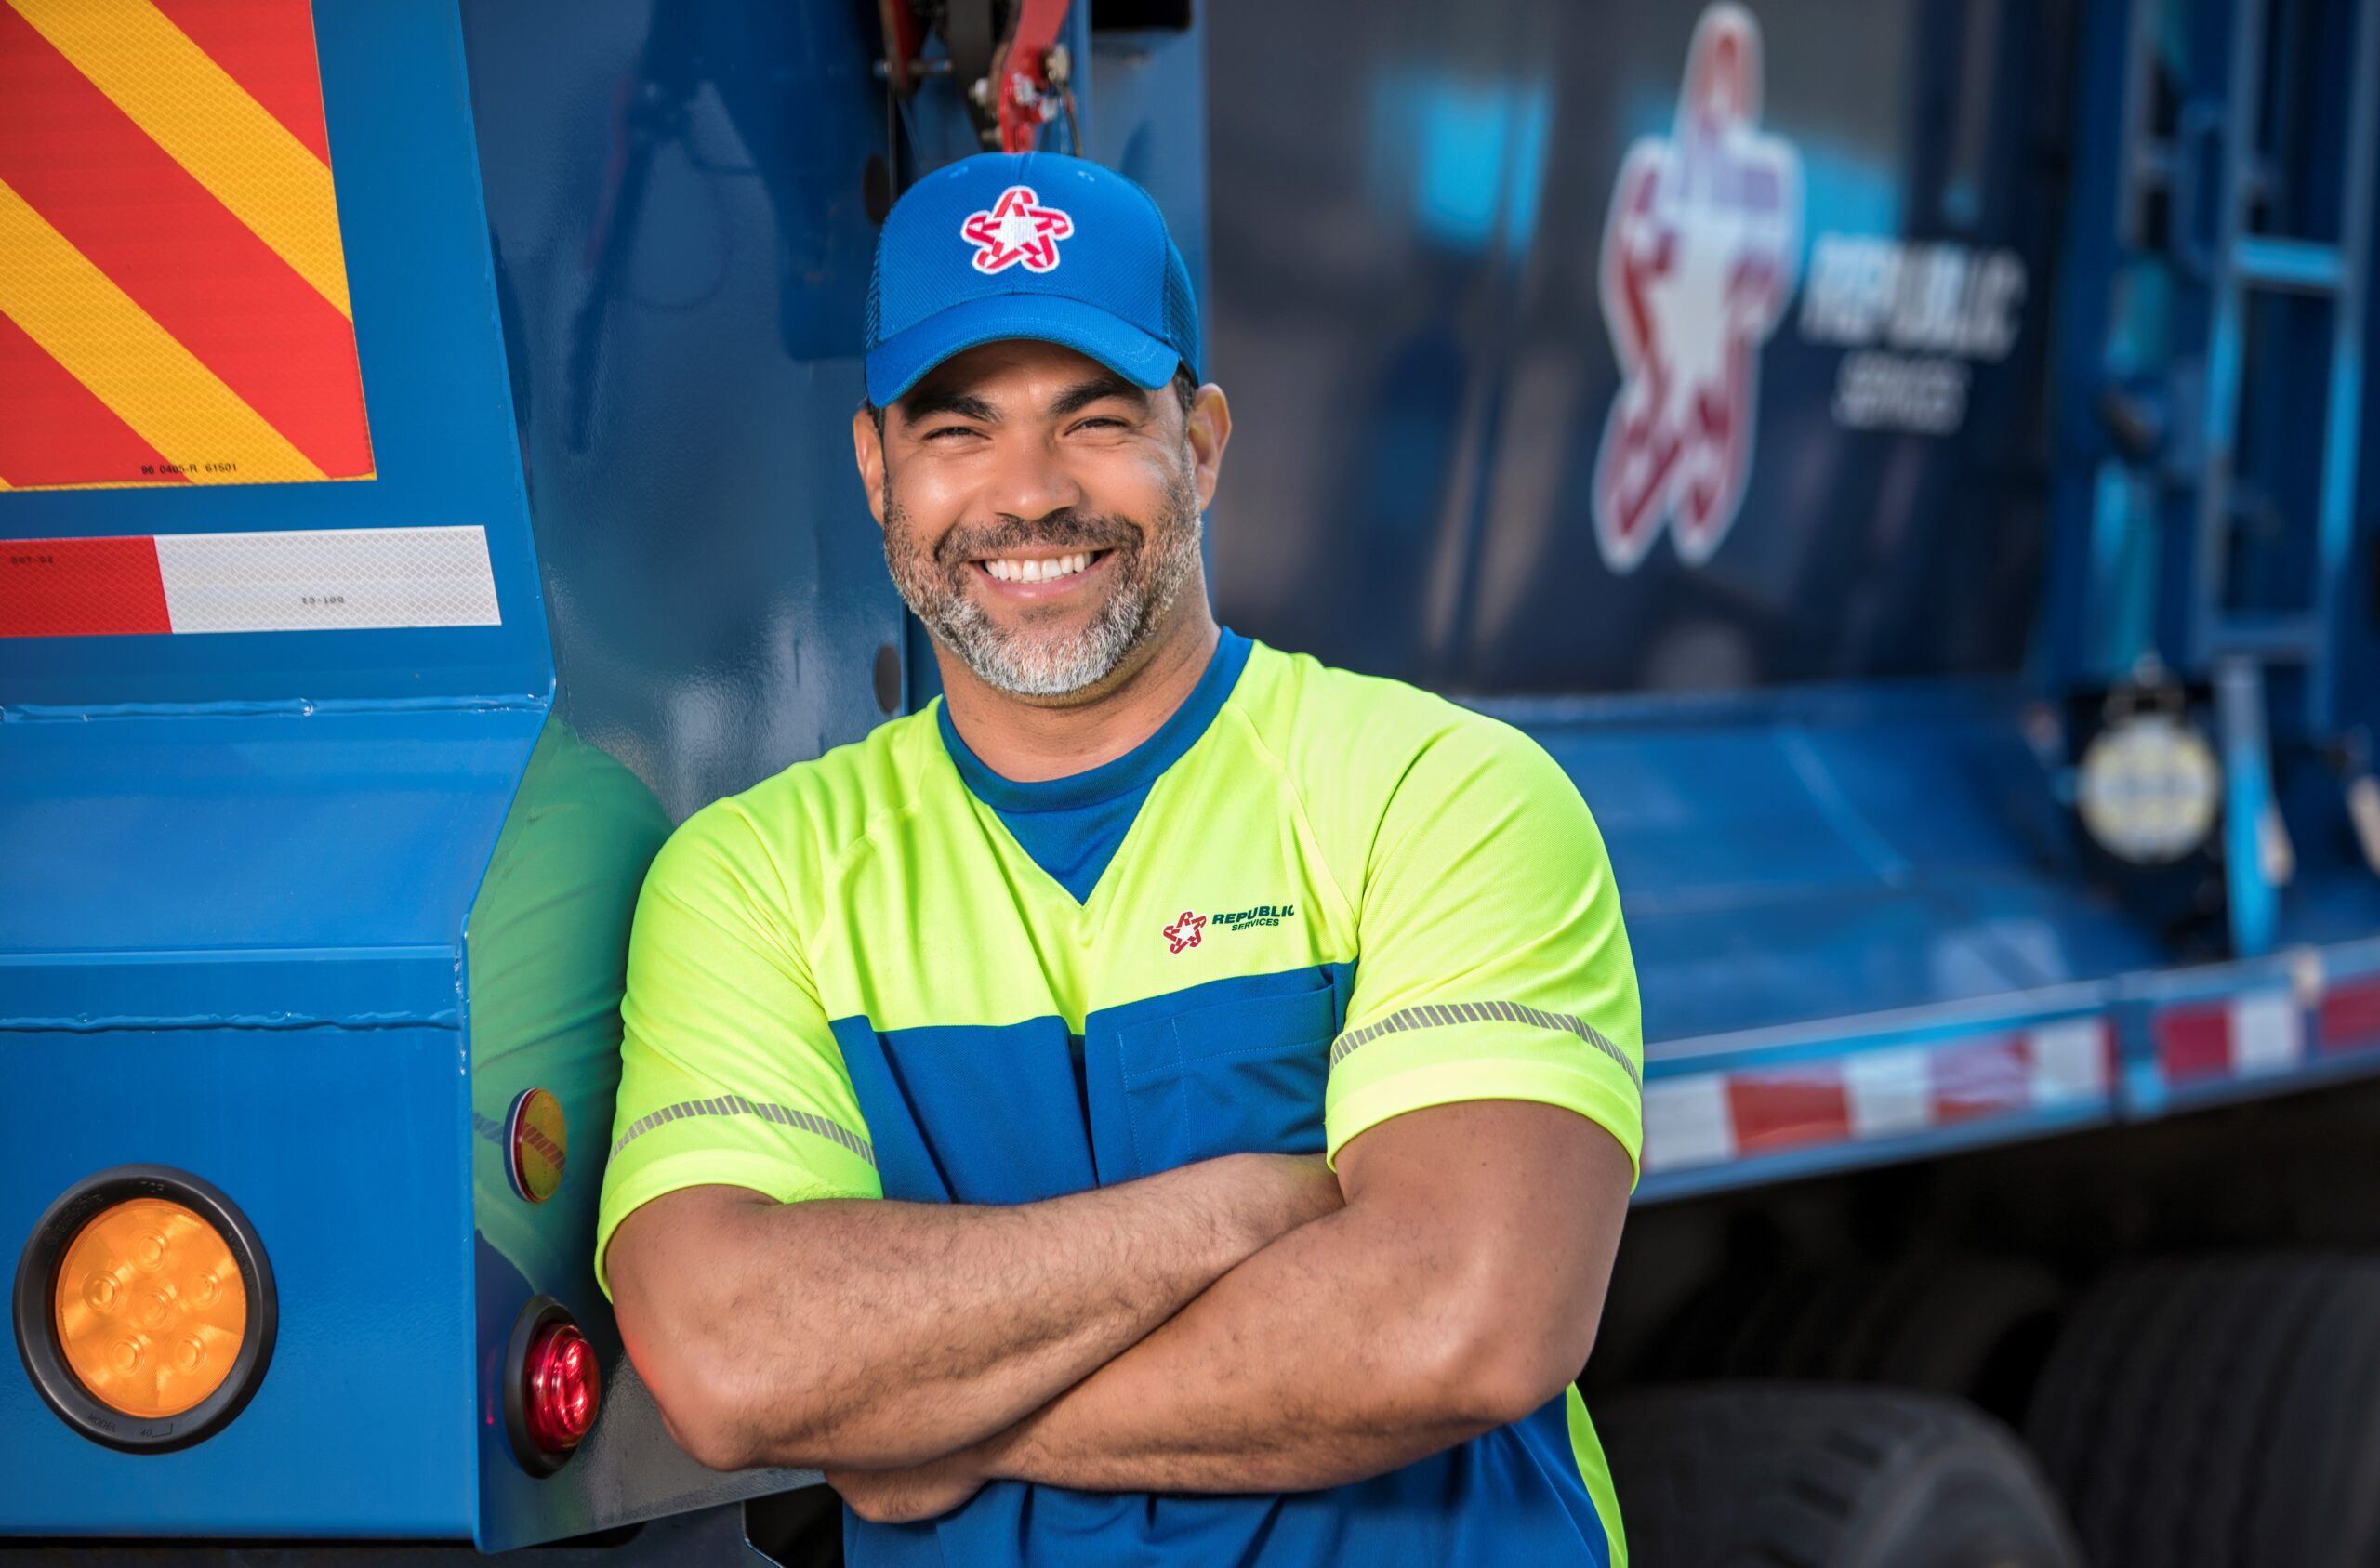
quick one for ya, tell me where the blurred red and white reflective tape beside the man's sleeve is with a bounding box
[1645,1019,2116,1173]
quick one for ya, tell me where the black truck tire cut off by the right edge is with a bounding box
[2026,1257,2380,1568]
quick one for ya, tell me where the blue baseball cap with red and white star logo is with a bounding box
[866,152,1197,407]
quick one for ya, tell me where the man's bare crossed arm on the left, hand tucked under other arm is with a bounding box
[612,1156,1338,1468]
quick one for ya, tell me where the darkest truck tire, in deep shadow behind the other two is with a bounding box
[1649,1254,2066,1423]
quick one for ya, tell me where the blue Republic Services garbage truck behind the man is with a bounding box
[0,0,2380,1568]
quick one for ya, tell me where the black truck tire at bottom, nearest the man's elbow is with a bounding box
[1594,1382,2082,1568]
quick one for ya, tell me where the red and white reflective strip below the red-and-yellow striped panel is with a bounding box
[0,526,500,638]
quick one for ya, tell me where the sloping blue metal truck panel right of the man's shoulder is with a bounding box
[1483,683,2163,1057]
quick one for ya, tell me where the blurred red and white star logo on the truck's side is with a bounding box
[1594,0,1802,571]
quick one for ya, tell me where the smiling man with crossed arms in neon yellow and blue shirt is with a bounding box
[598,154,1642,1568]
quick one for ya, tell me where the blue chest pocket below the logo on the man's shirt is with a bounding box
[1100,970,1340,1180]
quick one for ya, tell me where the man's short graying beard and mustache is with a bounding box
[885,481,1199,697]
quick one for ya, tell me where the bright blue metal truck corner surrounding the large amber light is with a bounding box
[0,5,552,1537]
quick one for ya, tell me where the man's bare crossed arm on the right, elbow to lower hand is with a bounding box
[966,1101,1631,1492]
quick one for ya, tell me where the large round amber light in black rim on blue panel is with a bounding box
[14,1166,273,1452]
